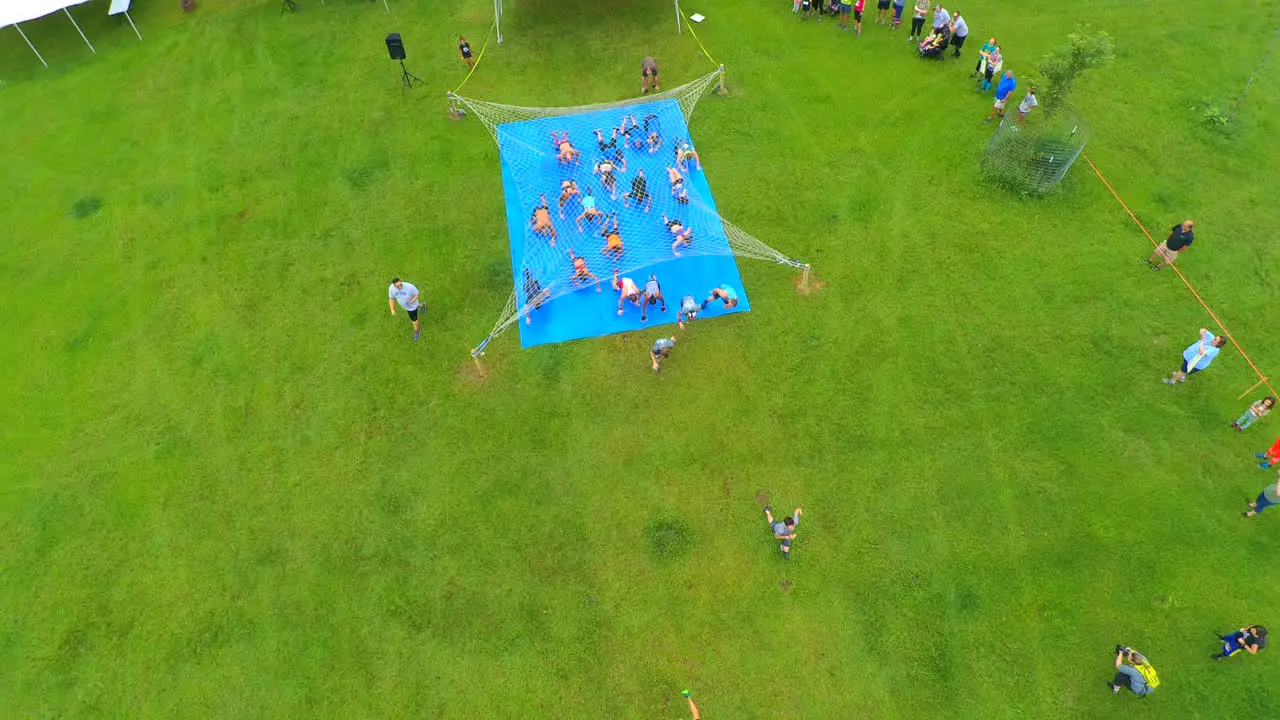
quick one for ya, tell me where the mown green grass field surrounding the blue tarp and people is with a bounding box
[0,0,1280,719]
